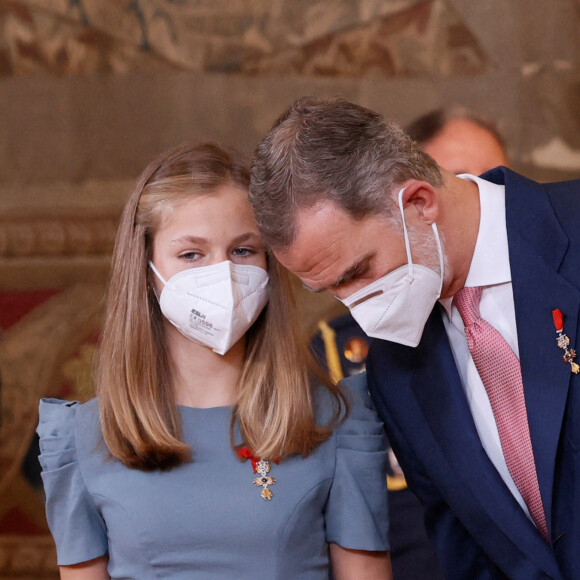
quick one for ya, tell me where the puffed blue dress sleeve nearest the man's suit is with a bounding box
[326,373,389,551]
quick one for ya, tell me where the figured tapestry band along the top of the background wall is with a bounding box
[0,0,486,78]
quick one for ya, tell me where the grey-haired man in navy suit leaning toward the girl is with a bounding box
[251,99,580,580]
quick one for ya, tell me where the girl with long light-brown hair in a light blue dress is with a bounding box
[38,143,391,580]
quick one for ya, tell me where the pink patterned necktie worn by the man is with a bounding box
[454,287,549,541]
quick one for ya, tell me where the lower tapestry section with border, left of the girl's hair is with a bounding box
[0,215,112,579]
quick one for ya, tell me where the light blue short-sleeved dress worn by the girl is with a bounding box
[38,377,388,580]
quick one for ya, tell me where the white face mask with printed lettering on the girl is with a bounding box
[149,260,270,355]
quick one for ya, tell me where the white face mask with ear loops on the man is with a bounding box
[341,188,444,347]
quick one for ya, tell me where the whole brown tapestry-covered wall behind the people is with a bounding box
[0,0,580,580]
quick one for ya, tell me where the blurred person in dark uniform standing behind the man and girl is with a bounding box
[312,107,508,580]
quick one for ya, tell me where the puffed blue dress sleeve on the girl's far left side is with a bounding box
[37,399,108,566]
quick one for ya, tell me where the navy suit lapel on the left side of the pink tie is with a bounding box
[403,307,553,570]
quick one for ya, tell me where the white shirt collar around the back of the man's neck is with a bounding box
[440,173,512,316]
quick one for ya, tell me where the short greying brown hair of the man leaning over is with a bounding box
[250,97,442,250]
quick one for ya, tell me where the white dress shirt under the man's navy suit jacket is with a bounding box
[440,174,533,521]
